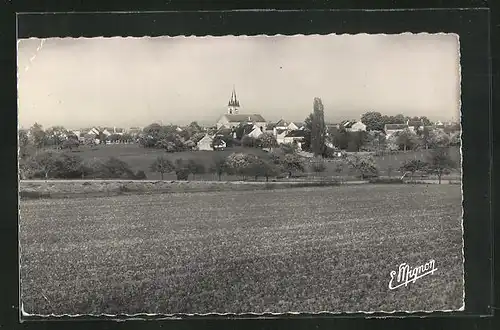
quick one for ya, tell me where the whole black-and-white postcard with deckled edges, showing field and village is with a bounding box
[17,33,465,316]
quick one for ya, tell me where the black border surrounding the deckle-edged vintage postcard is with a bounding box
[0,1,494,328]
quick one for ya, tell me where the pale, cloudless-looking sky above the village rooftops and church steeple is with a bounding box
[18,34,460,129]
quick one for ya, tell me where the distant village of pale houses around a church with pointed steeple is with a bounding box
[20,89,460,157]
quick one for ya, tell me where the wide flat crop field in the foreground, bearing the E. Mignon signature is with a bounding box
[20,185,463,314]
